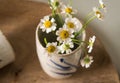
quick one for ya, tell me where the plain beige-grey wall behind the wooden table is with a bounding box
[30,0,120,73]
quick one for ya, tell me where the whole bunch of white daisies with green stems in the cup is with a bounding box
[39,0,106,68]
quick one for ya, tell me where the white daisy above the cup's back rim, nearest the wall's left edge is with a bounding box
[61,5,77,16]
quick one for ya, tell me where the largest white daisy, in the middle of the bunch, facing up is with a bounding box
[56,28,74,43]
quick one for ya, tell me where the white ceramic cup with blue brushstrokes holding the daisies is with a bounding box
[36,23,86,79]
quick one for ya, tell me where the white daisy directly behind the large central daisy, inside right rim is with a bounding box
[63,17,82,32]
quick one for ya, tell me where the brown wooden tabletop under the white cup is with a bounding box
[0,0,119,83]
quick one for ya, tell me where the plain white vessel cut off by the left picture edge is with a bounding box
[0,31,15,68]
